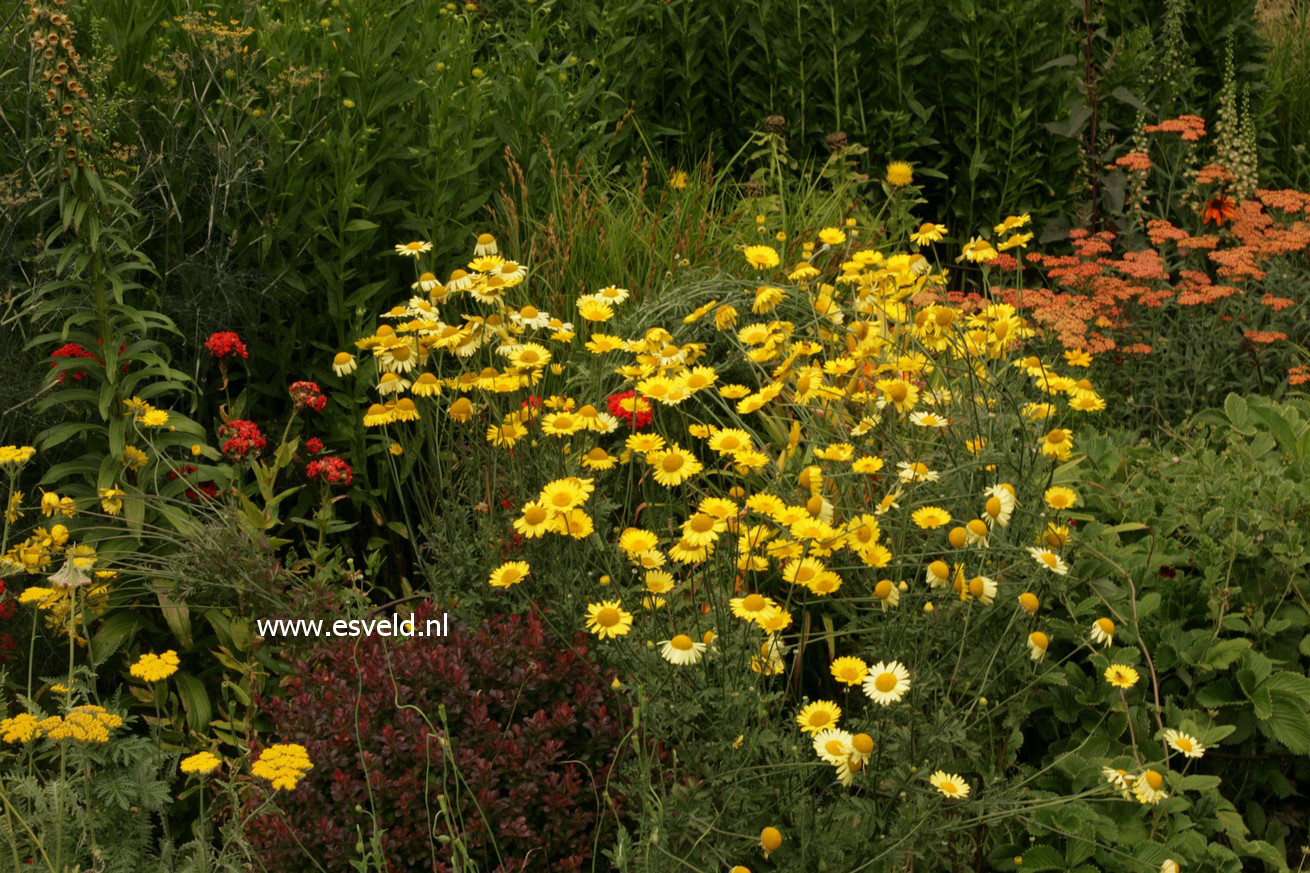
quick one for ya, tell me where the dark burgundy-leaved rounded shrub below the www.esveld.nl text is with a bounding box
[248,603,629,873]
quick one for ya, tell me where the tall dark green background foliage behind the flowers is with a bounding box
[0,0,1289,429]
